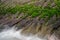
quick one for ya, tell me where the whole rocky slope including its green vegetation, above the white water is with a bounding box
[0,0,60,40]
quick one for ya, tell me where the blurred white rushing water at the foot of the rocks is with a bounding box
[0,25,45,40]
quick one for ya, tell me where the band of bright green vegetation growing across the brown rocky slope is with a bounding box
[0,0,60,18]
